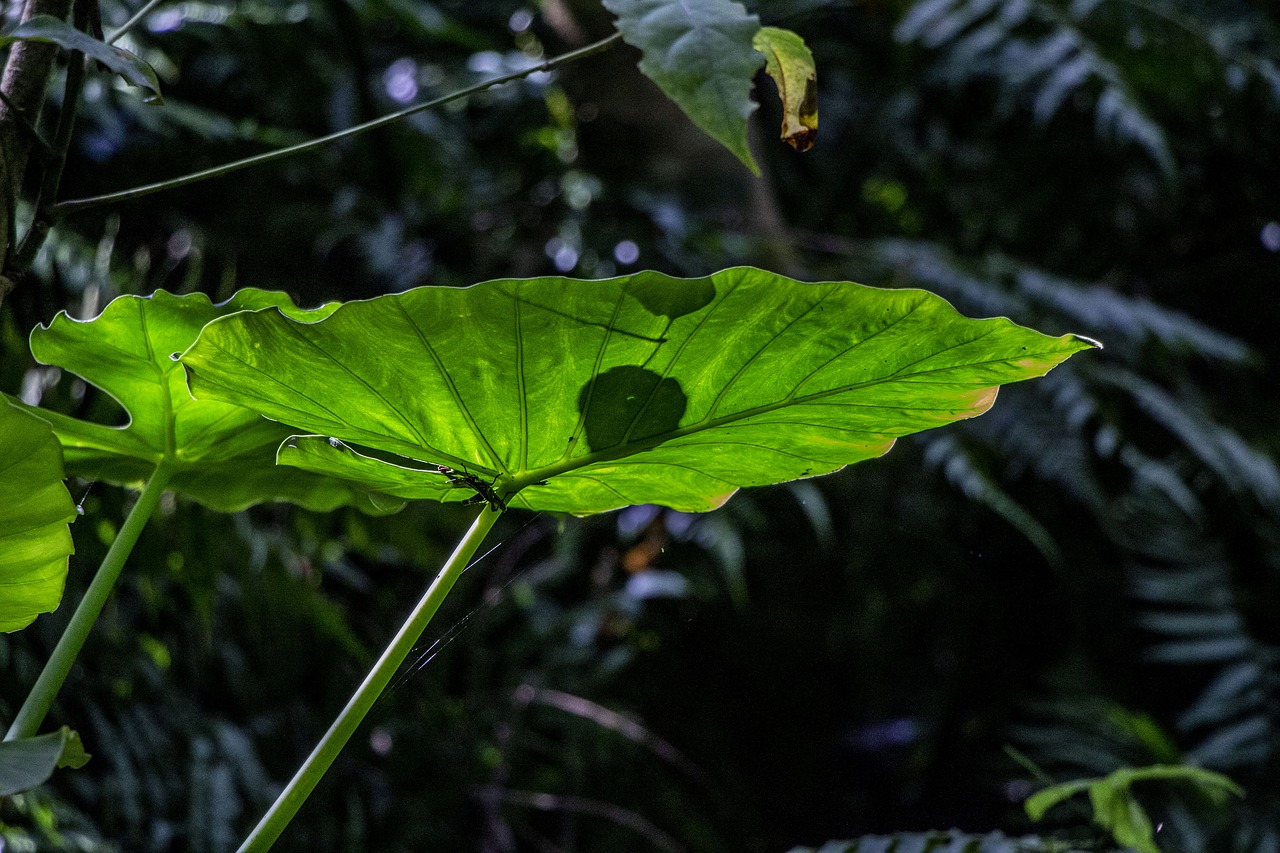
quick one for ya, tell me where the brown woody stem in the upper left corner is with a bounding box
[0,0,72,298]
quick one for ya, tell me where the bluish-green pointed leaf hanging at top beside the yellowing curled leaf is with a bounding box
[604,0,764,174]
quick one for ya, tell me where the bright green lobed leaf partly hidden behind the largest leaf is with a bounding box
[31,289,401,511]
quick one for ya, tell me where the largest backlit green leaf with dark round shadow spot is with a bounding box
[182,268,1094,514]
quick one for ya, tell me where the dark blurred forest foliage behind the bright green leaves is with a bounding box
[0,0,1280,852]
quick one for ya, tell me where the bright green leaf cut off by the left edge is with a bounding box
[0,398,76,631]
